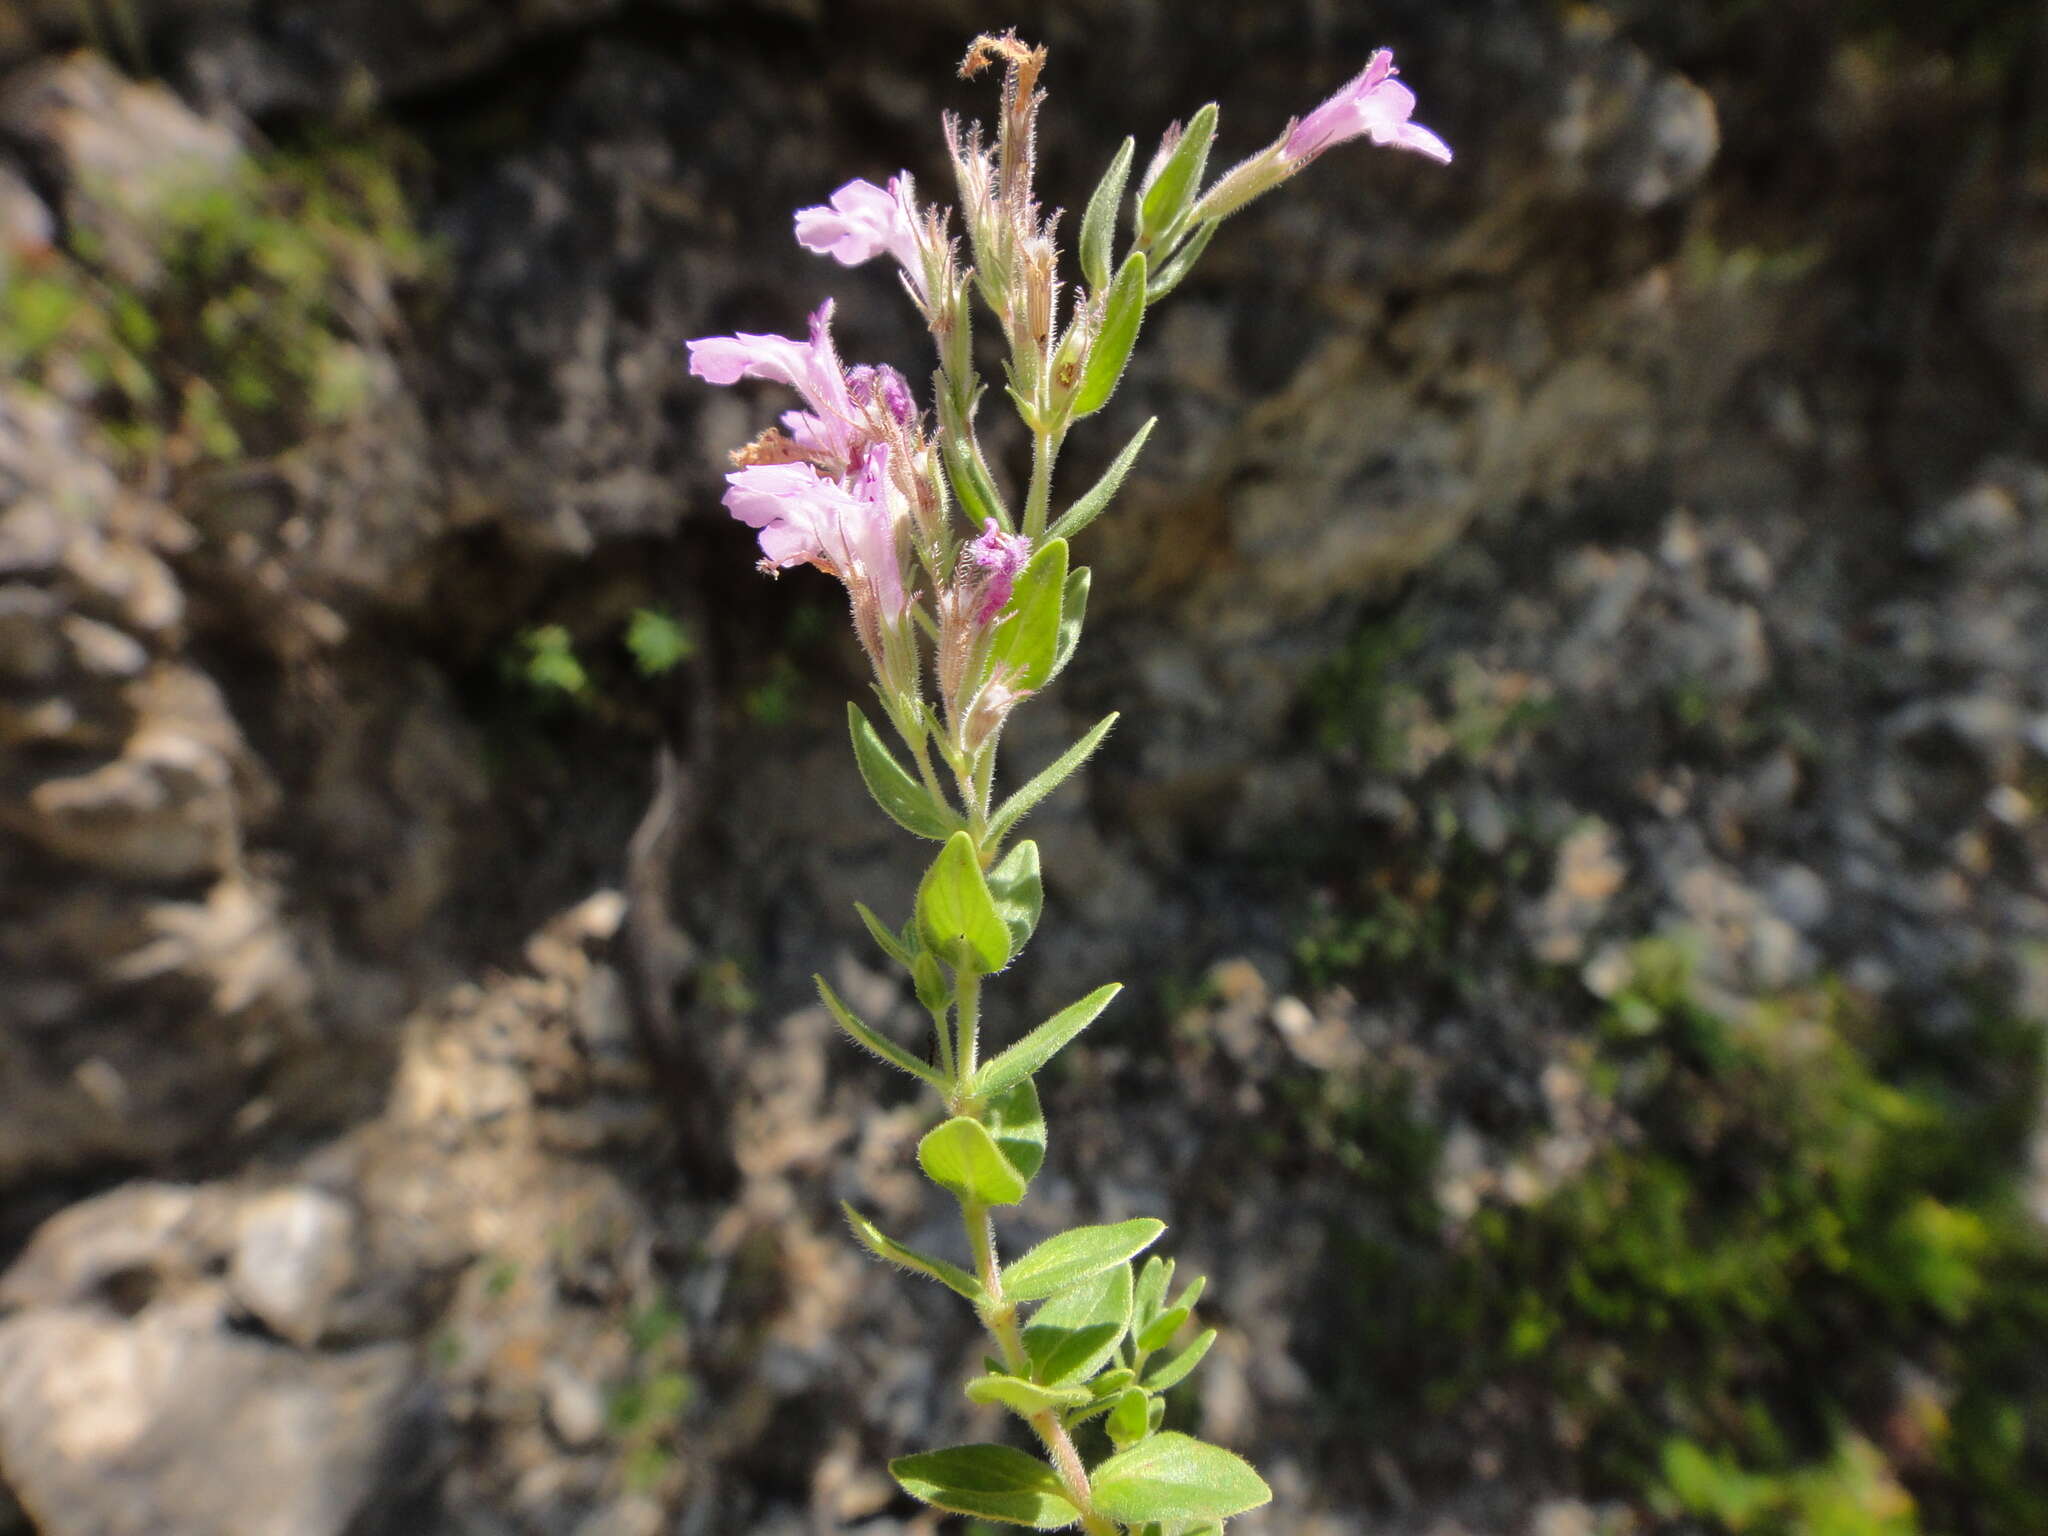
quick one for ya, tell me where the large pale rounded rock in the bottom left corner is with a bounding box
[0,1184,430,1536]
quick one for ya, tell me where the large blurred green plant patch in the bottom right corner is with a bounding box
[1333,944,2048,1536]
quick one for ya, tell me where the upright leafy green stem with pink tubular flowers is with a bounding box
[690,33,1450,1536]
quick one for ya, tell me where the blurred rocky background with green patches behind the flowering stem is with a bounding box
[0,0,2048,1536]
